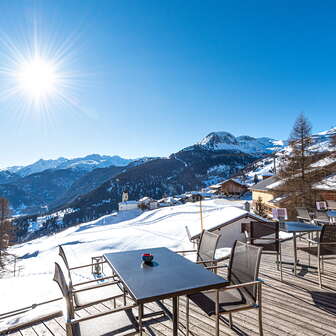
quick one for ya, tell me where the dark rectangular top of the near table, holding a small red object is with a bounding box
[104,247,229,304]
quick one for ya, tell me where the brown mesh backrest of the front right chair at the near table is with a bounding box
[228,240,262,302]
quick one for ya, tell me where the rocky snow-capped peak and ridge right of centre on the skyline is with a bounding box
[193,132,284,155]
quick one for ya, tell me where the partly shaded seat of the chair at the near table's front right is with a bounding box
[188,289,255,316]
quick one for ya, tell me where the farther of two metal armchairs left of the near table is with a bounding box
[59,245,126,309]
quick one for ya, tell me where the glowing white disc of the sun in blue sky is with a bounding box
[16,57,58,102]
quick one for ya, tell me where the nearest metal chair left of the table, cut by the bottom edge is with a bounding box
[53,263,142,336]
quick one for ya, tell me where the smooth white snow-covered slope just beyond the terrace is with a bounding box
[0,200,245,313]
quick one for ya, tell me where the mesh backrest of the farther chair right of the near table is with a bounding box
[197,230,220,267]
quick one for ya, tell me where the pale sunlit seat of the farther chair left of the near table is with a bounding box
[74,285,123,307]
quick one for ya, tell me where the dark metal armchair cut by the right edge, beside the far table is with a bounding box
[300,224,336,288]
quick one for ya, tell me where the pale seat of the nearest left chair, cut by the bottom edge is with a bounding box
[71,309,139,336]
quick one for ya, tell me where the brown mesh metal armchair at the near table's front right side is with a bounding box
[186,241,263,336]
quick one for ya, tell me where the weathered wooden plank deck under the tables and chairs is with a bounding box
[3,241,336,336]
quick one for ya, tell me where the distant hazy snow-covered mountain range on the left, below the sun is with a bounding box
[6,154,133,177]
